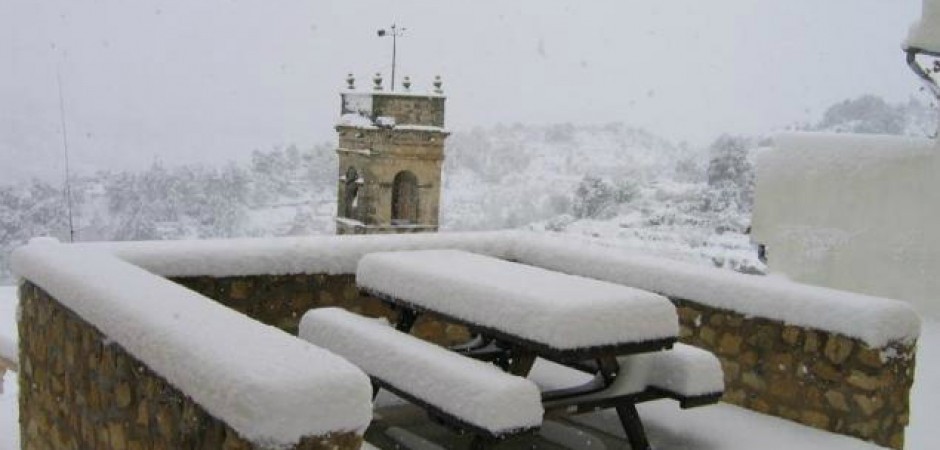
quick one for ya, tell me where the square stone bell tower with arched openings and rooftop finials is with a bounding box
[336,74,448,234]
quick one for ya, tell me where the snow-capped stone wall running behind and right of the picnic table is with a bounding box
[11,232,919,448]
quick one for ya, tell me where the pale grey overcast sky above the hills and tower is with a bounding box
[0,0,924,180]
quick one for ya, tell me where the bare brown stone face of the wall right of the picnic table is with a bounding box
[673,300,915,449]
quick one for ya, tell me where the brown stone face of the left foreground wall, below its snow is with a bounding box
[19,282,362,450]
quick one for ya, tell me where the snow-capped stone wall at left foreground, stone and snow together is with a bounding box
[13,243,372,449]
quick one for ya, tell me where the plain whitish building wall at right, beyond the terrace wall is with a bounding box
[752,133,940,317]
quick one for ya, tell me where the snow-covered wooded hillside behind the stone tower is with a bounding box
[0,96,933,283]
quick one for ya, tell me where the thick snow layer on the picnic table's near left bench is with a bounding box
[299,308,542,437]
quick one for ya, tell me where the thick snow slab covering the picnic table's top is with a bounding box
[356,250,679,350]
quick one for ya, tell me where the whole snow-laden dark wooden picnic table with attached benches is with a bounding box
[301,250,724,450]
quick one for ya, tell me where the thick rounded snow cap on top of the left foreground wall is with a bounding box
[13,242,372,447]
